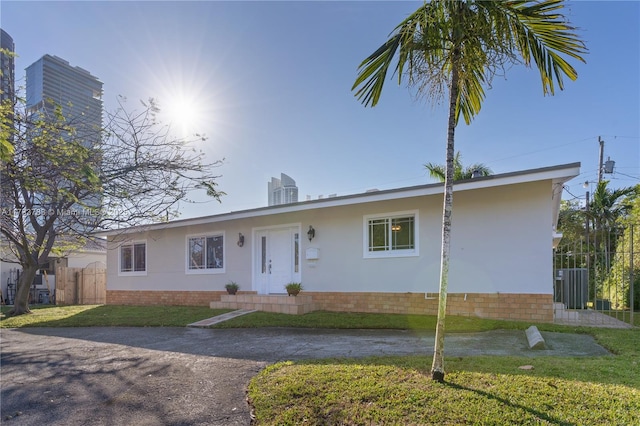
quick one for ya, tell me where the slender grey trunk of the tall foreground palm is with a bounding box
[431,49,459,382]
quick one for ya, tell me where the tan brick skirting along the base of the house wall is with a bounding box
[107,290,553,322]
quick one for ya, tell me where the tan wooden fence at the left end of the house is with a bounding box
[56,262,107,305]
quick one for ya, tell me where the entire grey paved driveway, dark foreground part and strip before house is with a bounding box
[0,327,608,426]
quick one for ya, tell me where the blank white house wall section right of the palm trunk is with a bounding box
[449,182,553,293]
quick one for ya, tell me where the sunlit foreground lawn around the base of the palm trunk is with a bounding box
[248,324,640,425]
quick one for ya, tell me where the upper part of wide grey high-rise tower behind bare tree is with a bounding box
[27,55,102,138]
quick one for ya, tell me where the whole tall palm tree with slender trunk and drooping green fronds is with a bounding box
[352,0,587,381]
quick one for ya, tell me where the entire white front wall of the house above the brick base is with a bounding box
[107,180,552,293]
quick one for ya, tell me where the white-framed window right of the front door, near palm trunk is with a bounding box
[363,210,419,258]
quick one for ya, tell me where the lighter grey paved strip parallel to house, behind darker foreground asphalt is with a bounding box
[2,327,609,362]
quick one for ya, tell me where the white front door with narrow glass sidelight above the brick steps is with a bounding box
[254,226,300,294]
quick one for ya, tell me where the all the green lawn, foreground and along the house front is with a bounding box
[0,306,640,425]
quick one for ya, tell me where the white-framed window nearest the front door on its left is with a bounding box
[186,232,225,274]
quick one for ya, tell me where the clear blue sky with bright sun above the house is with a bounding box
[0,0,640,218]
